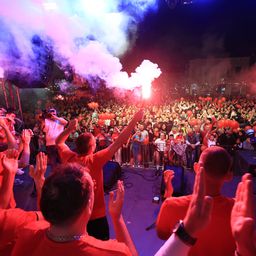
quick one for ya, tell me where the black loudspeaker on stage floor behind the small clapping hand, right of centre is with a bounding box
[161,165,185,196]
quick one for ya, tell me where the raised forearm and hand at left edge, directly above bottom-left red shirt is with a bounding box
[0,149,18,209]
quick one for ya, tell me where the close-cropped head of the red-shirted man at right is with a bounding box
[199,146,232,178]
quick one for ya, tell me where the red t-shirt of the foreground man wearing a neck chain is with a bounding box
[12,222,131,256]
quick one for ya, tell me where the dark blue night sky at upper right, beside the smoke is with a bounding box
[122,0,256,72]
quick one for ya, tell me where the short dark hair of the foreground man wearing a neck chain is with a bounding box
[40,163,93,225]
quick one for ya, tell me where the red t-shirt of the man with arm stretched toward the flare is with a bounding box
[58,145,112,220]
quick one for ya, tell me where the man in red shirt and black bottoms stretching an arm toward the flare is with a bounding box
[56,110,143,240]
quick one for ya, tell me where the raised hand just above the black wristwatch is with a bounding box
[184,167,213,237]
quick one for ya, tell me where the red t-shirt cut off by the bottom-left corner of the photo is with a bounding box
[0,208,38,256]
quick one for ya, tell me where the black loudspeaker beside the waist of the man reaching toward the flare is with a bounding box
[103,161,122,192]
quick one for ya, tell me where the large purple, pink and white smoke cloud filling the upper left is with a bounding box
[0,0,157,89]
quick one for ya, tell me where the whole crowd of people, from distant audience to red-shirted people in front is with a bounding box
[0,97,256,256]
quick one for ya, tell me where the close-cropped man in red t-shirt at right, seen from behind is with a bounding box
[156,147,235,256]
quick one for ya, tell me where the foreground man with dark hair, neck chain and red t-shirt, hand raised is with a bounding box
[12,163,138,256]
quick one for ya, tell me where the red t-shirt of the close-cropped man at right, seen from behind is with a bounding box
[156,195,236,256]
